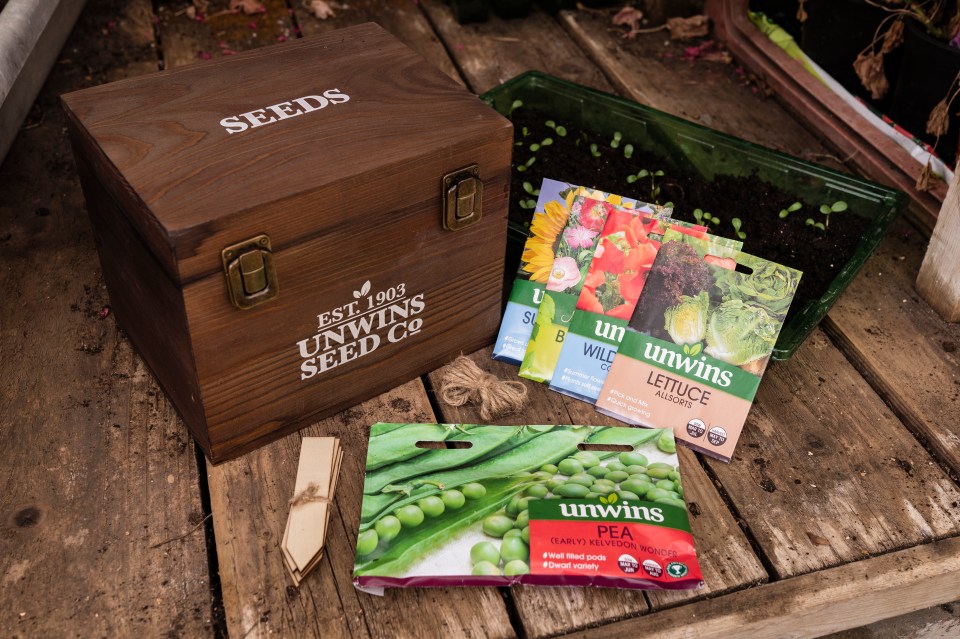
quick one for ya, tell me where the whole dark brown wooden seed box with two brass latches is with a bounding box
[62,24,512,462]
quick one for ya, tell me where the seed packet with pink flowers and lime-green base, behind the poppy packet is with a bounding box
[520,195,670,382]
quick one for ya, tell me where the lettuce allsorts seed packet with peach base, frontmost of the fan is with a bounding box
[597,236,801,461]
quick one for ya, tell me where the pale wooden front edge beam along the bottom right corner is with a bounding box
[567,538,960,639]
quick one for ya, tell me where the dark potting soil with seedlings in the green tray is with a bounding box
[510,108,869,320]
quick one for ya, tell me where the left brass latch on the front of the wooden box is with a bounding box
[220,235,280,309]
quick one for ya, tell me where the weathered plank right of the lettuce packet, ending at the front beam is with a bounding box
[709,329,960,579]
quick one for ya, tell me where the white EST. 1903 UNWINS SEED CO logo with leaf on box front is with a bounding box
[297,280,426,380]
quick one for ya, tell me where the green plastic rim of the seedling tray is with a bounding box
[480,71,908,361]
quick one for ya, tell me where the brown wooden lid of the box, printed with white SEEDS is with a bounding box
[62,23,511,284]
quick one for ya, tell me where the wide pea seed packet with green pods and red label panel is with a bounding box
[353,424,703,594]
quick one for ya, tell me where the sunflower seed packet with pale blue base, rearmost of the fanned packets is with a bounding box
[493,179,636,366]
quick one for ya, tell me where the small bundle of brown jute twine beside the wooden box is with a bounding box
[439,355,527,420]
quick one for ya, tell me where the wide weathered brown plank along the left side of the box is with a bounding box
[0,0,212,637]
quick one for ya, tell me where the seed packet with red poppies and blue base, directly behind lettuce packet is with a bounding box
[550,225,743,404]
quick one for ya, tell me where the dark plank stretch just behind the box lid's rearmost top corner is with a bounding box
[294,0,463,84]
